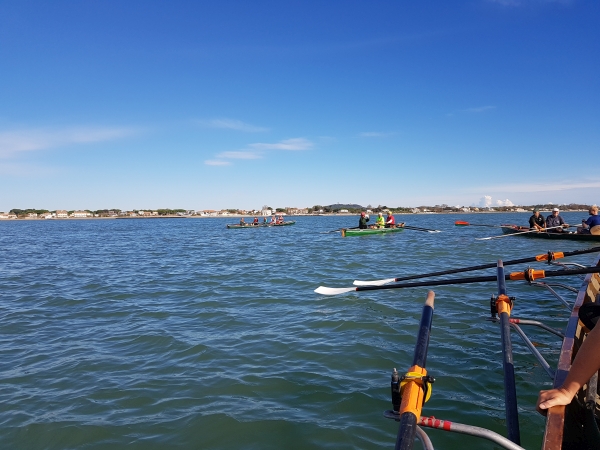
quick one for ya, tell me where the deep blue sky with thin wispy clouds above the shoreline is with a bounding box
[0,0,600,210]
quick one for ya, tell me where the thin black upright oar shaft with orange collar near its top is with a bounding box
[496,260,521,444]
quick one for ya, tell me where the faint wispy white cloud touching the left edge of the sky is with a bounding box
[0,127,139,158]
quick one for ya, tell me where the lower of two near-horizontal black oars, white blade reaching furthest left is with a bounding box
[315,266,600,295]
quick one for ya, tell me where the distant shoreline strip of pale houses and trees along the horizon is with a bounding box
[0,203,591,220]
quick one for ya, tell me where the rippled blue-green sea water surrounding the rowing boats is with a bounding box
[0,213,594,449]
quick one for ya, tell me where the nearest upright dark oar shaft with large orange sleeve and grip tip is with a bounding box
[395,291,435,450]
